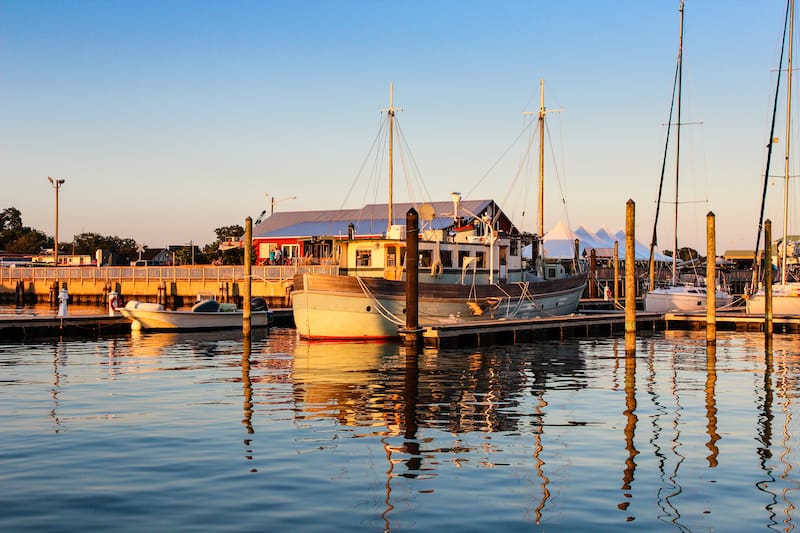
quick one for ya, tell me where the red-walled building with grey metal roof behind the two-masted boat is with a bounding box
[253,200,520,265]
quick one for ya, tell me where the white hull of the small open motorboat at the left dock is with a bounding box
[118,304,269,331]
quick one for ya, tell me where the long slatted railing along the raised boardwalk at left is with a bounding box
[0,265,338,283]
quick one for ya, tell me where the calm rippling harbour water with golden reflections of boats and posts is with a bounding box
[0,316,800,531]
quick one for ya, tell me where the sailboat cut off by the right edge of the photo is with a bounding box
[746,0,800,315]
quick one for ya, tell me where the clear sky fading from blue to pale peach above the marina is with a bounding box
[0,0,797,253]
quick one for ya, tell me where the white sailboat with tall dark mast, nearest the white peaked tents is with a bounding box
[644,0,733,313]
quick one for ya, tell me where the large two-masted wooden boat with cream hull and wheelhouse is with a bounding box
[291,83,587,339]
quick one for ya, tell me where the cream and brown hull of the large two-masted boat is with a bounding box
[292,274,585,339]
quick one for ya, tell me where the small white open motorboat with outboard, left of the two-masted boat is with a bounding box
[118,298,269,331]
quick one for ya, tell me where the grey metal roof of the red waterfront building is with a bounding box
[253,200,517,239]
